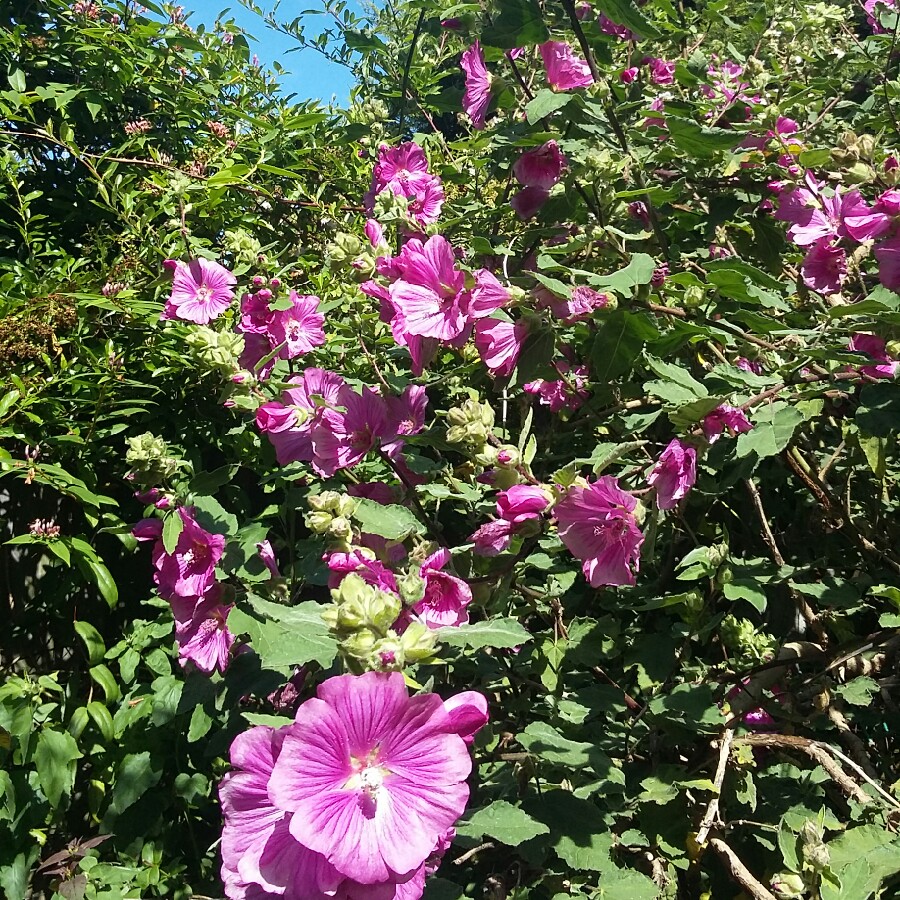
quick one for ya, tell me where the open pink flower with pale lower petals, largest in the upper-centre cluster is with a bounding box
[390,234,468,343]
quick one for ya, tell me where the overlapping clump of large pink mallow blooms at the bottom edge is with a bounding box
[219,672,487,900]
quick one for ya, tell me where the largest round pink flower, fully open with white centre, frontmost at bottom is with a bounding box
[264,672,482,884]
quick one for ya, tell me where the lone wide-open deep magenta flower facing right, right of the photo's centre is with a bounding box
[554,475,644,587]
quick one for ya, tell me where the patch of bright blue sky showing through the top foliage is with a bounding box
[180,0,362,106]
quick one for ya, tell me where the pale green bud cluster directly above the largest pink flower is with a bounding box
[322,572,435,672]
